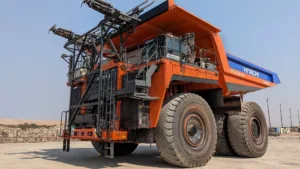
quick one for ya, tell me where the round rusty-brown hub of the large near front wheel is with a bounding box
[184,114,205,147]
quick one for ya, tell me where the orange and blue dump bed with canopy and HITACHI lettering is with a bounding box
[114,0,280,95]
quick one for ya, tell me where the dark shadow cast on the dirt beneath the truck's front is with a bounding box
[7,145,174,169]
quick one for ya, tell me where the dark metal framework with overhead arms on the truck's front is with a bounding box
[50,0,155,151]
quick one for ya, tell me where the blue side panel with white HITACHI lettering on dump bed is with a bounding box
[227,54,280,84]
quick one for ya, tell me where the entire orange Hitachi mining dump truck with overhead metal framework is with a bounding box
[50,0,280,167]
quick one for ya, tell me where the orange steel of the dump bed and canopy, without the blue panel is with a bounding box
[108,1,275,96]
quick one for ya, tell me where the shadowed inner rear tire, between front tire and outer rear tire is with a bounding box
[215,114,236,156]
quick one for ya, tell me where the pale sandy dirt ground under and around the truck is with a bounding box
[0,135,300,169]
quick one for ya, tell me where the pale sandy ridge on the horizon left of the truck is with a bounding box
[0,118,60,126]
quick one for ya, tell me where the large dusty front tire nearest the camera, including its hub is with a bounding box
[155,93,217,168]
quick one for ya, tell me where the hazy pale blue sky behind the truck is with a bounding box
[0,0,300,126]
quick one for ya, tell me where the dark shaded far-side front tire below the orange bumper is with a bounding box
[92,141,138,156]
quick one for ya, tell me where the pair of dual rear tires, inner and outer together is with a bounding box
[216,102,268,158]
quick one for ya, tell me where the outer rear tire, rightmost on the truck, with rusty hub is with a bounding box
[228,102,268,158]
